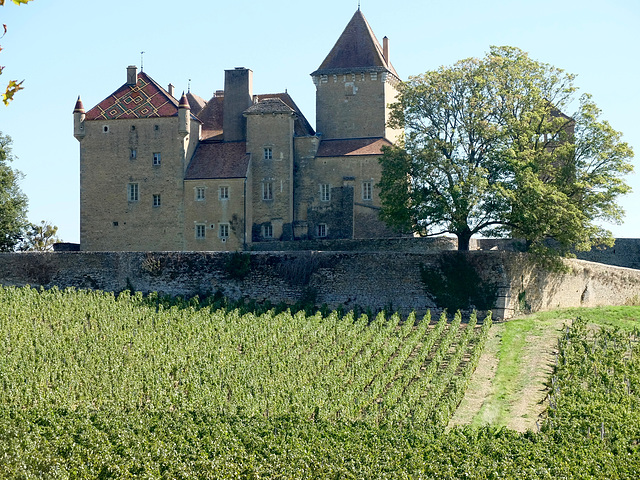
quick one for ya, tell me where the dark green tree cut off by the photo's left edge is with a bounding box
[0,132,28,252]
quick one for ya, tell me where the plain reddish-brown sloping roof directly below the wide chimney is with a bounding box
[184,141,250,180]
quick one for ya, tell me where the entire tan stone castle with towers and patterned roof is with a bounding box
[73,10,401,251]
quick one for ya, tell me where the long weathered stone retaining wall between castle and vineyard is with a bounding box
[0,251,640,318]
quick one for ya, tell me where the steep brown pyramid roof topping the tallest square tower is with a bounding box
[311,9,399,78]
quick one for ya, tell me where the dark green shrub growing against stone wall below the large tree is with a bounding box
[420,253,498,312]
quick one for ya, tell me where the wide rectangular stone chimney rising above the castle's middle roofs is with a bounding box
[222,67,253,142]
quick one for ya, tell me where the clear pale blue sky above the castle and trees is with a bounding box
[0,0,640,242]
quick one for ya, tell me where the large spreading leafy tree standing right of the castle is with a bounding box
[379,47,633,253]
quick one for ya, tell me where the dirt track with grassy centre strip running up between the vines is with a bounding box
[449,307,640,432]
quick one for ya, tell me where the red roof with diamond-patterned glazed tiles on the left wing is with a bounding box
[85,72,178,120]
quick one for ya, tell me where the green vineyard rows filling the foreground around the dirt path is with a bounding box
[0,288,640,478]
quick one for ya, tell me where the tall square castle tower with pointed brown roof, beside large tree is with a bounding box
[311,10,401,142]
